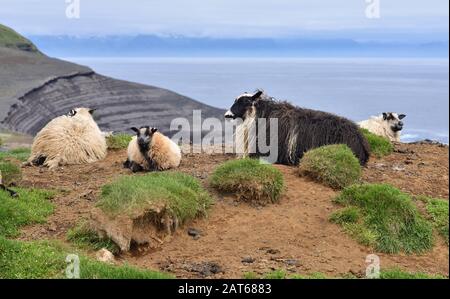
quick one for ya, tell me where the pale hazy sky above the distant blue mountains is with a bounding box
[0,0,449,38]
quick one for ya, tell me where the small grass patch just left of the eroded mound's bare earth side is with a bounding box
[67,222,120,254]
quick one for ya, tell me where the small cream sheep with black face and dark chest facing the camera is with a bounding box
[124,126,181,172]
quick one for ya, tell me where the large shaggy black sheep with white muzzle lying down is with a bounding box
[225,90,369,165]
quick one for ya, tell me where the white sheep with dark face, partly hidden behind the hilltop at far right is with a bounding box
[358,112,406,142]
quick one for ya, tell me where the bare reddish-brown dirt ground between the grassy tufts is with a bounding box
[15,144,449,278]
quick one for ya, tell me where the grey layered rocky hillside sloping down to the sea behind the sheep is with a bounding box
[0,26,223,134]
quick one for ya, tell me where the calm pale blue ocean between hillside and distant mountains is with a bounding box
[67,57,449,144]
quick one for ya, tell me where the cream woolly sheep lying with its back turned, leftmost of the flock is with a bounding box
[28,108,107,169]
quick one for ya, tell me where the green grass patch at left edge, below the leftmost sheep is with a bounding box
[0,188,54,237]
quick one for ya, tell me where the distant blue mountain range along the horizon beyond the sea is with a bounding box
[29,35,449,57]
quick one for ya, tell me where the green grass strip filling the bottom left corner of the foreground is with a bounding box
[0,236,172,279]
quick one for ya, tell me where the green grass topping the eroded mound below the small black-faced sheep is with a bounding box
[98,172,212,223]
